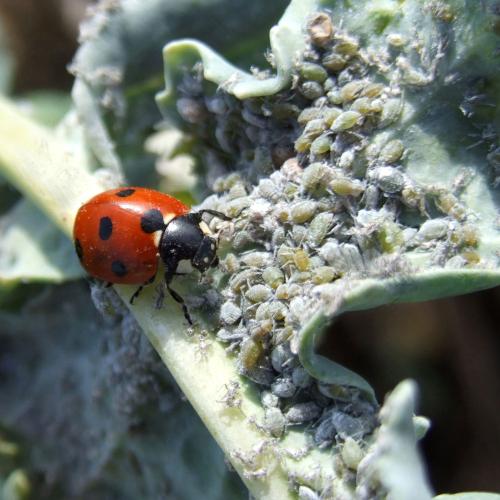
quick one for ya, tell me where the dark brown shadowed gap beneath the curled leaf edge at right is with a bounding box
[321,289,500,493]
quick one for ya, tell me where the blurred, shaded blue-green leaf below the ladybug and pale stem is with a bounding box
[0,283,246,500]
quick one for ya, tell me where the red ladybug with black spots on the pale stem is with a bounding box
[73,187,229,325]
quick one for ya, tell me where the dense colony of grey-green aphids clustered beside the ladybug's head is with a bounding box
[169,7,484,446]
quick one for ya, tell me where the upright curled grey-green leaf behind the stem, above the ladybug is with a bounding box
[72,0,287,184]
